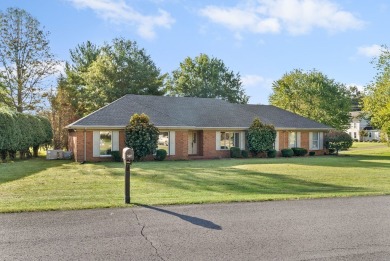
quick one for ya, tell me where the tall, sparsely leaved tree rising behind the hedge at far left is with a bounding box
[0,8,58,112]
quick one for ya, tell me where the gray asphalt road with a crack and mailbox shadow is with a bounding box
[0,196,390,260]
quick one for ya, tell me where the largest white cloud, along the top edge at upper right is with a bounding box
[200,0,364,35]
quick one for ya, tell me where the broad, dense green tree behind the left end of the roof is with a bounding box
[66,38,165,116]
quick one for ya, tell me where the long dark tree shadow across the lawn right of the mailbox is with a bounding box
[139,169,371,195]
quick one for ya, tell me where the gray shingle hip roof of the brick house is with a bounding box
[68,94,330,129]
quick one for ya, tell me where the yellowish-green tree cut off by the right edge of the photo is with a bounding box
[363,46,390,137]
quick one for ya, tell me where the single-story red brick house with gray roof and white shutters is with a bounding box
[67,94,331,162]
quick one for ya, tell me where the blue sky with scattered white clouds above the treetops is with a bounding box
[0,0,390,104]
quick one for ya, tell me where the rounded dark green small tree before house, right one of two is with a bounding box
[248,118,276,156]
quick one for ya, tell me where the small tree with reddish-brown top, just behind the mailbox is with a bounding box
[126,113,160,161]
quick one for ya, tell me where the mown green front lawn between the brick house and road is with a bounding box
[0,146,390,212]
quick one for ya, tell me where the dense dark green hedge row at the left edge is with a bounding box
[0,108,53,160]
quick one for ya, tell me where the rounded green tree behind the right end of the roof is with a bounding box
[269,69,351,130]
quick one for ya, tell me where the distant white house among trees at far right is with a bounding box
[346,111,380,141]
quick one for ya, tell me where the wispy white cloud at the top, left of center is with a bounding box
[68,0,175,39]
